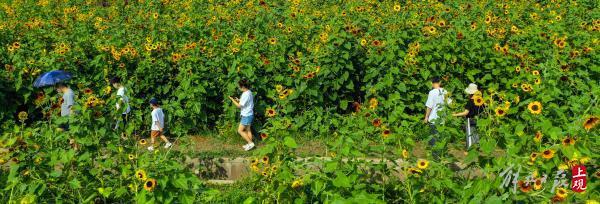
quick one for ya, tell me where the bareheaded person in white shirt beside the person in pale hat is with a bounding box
[423,77,451,146]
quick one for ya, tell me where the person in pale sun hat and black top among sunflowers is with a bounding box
[452,83,485,149]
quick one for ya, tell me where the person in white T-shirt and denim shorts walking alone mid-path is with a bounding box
[229,79,254,151]
